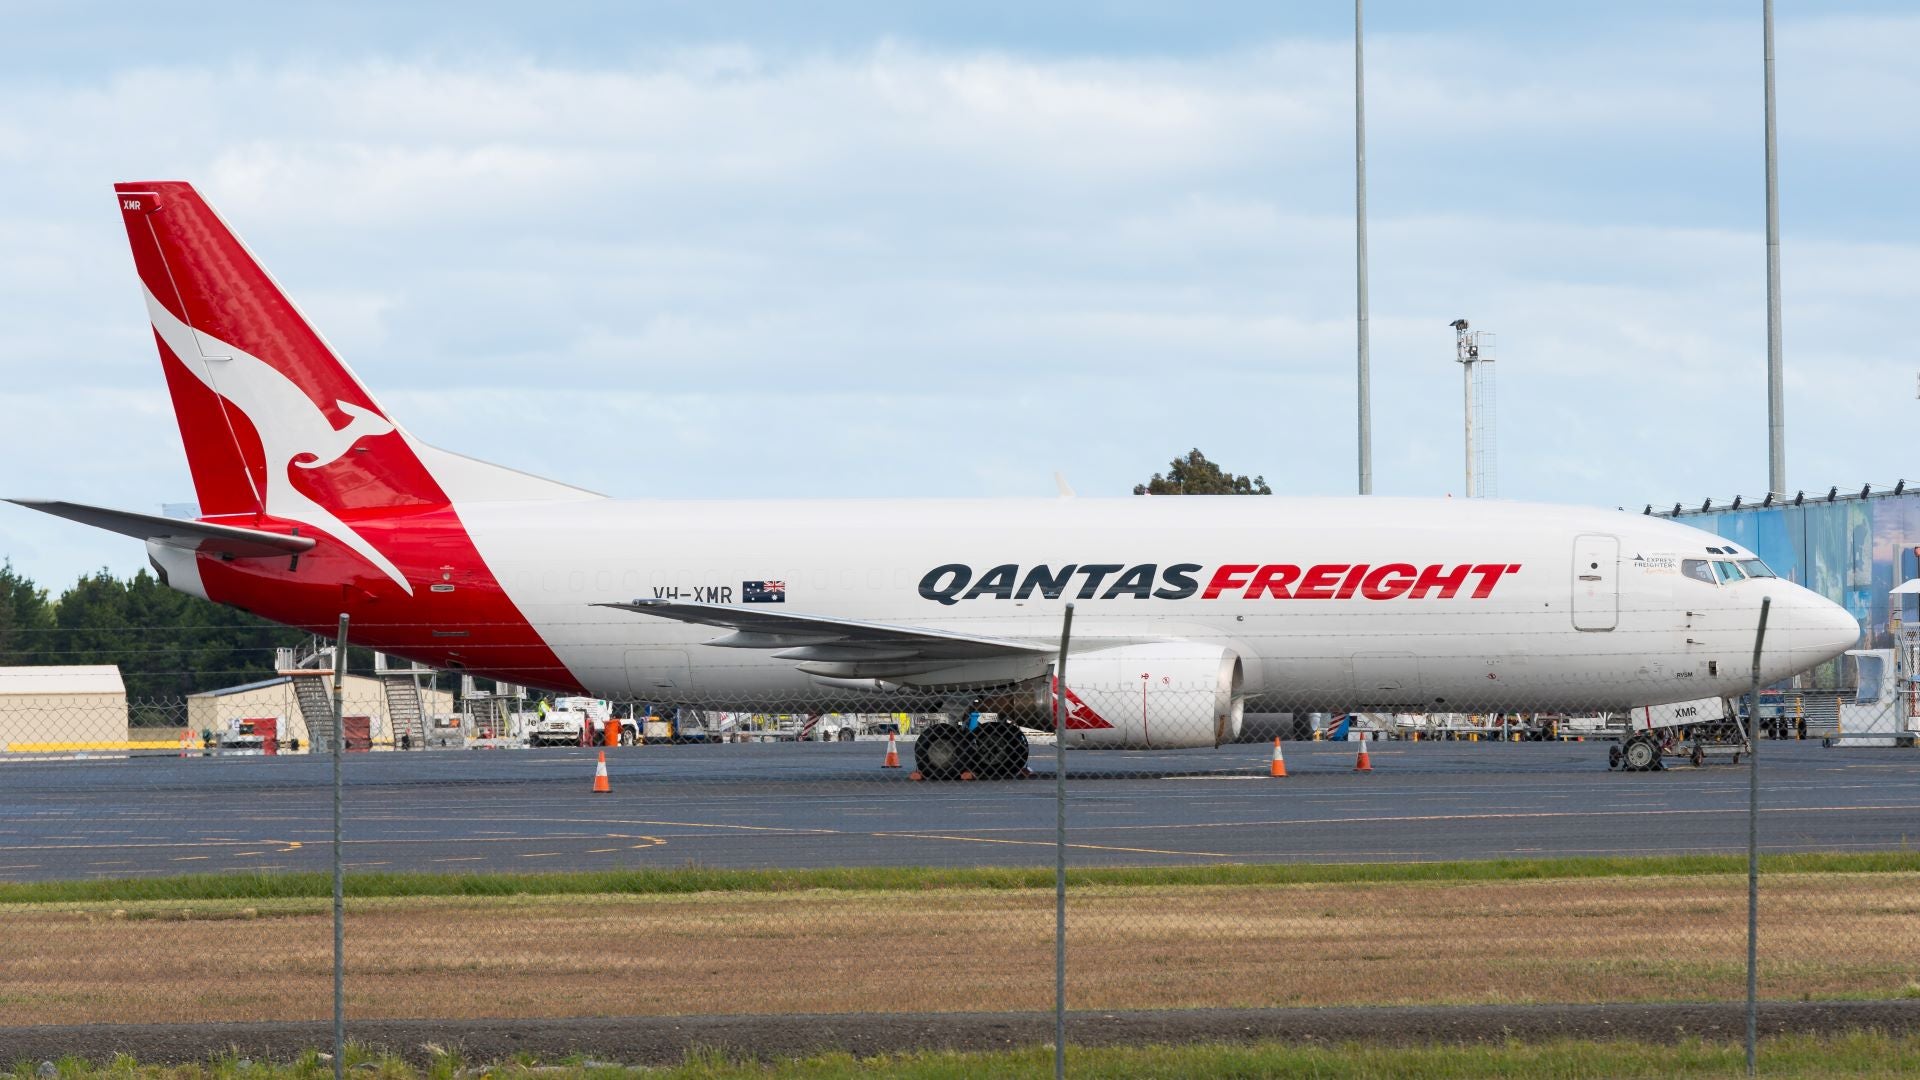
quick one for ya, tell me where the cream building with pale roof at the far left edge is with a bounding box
[0,663,129,751]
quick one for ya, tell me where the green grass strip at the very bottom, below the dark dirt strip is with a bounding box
[13,1032,1920,1080]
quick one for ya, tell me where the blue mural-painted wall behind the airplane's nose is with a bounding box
[1676,492,1920,688]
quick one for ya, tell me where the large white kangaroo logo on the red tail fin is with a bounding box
[146,292,413,596]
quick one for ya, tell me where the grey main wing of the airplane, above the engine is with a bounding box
[595,600,1056,665]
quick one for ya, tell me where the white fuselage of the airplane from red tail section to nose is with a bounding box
[449,498,1859,711]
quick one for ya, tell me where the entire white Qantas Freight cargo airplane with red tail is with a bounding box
[3,181,1860,778]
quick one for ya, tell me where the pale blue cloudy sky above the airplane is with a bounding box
[0,0,1920,592]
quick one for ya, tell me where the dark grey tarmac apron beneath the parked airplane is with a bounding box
[0,742,1920,882]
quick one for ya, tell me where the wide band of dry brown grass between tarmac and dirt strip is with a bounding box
[0,874,1920,1024]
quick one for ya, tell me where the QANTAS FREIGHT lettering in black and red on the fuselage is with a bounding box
[920,563,1521,605]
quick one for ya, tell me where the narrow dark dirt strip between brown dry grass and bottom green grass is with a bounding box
[0,999,1920,1067]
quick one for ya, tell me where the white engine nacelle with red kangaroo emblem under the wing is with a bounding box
[1046,642,1246,749]
